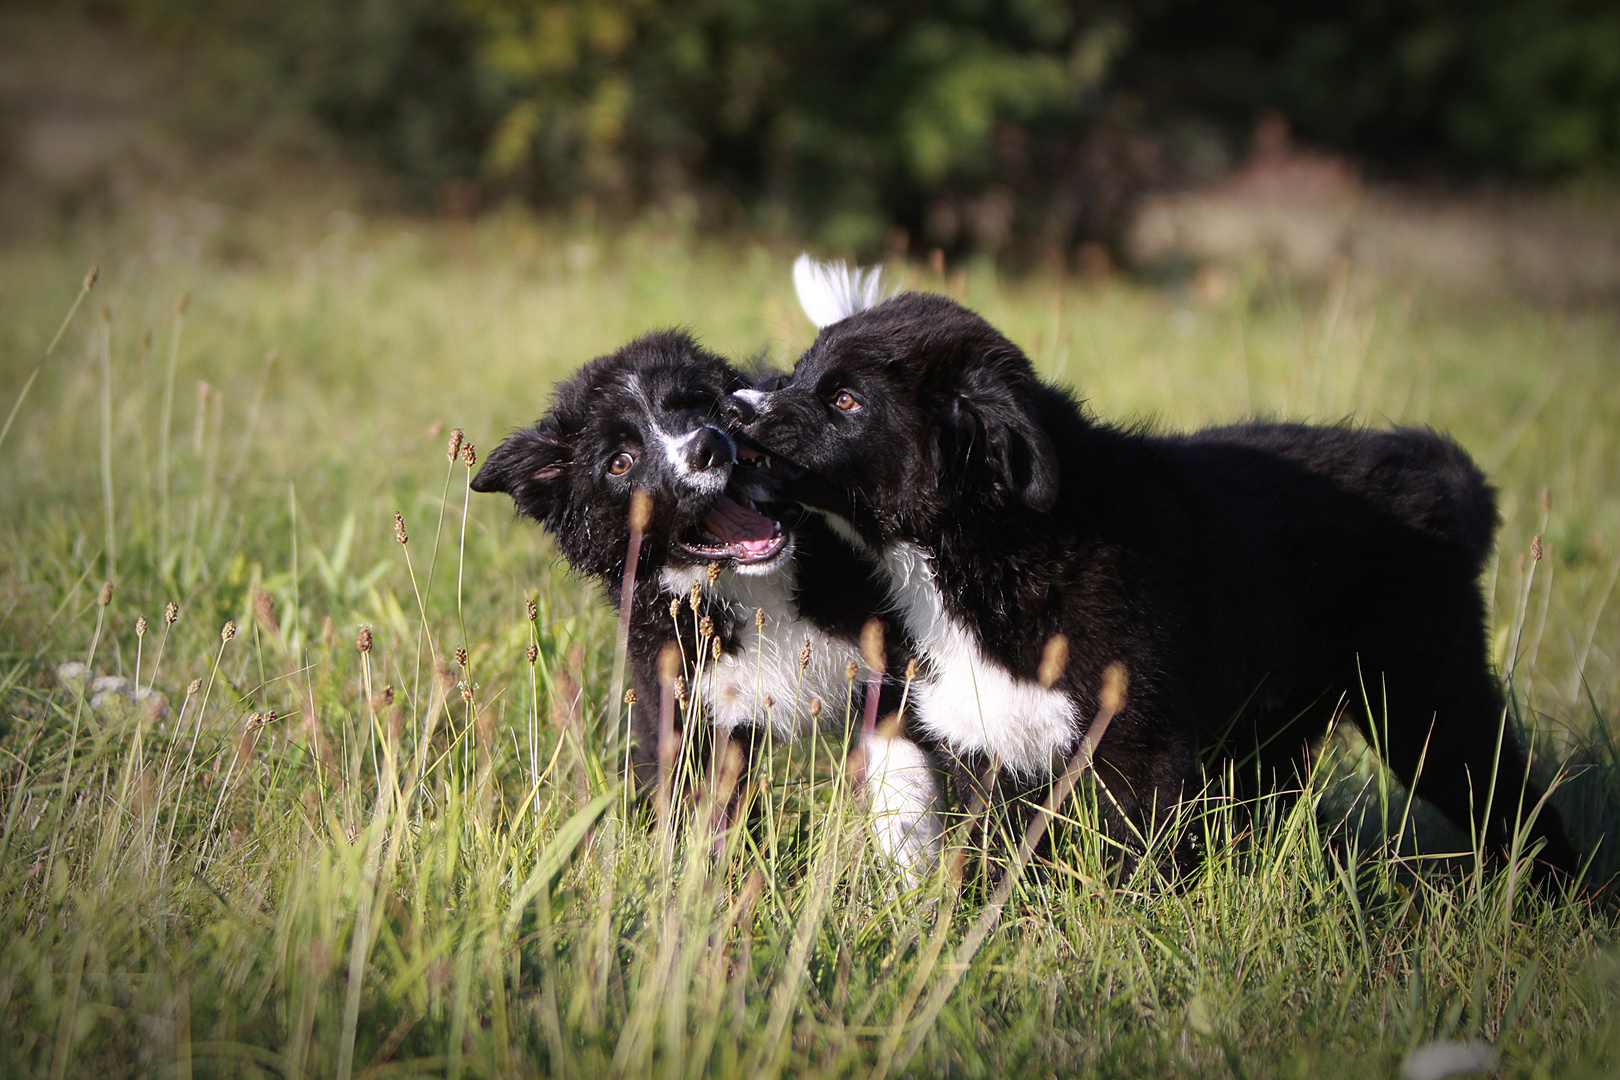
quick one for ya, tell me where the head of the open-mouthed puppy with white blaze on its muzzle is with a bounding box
[473,332,791,581]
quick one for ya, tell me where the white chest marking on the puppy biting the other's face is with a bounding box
[883,542,1076,777]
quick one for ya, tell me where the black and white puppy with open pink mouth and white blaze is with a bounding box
[473,332,940,868]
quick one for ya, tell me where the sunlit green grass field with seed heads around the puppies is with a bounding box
[0,207,1620,1080]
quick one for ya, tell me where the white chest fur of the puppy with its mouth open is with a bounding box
[661,567,867,738]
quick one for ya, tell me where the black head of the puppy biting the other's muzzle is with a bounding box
[731,293,1058,546]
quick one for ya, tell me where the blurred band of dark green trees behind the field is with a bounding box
[85,0,1620,253]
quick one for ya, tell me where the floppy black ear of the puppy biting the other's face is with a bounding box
[944,377,1058,510]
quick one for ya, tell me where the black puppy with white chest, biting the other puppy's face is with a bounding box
[732,275,1578,873]
